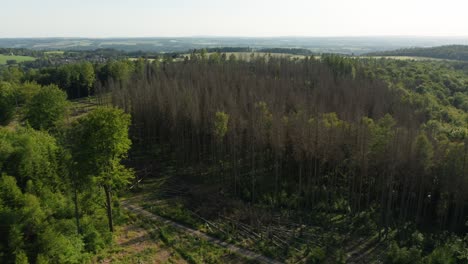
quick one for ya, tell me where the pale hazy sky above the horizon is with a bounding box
[0,0,468,38]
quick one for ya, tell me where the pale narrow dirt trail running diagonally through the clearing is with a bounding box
[122,200,282,264]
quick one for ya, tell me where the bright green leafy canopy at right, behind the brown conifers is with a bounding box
[363,59,468,133]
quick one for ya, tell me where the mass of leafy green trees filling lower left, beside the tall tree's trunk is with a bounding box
[0,121,117,263]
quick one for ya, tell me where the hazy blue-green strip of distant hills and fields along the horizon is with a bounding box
[0,37,468,55]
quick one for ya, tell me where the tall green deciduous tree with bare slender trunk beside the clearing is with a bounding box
[72,107,132,232]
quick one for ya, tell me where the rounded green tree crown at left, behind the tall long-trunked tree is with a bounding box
[25,85,68,130]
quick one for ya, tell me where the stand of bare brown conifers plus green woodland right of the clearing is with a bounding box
[107,54,468,263]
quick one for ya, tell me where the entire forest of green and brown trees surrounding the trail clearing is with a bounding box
[0,49,468,263]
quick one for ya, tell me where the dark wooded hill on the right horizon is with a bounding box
[366,45,468,61]
